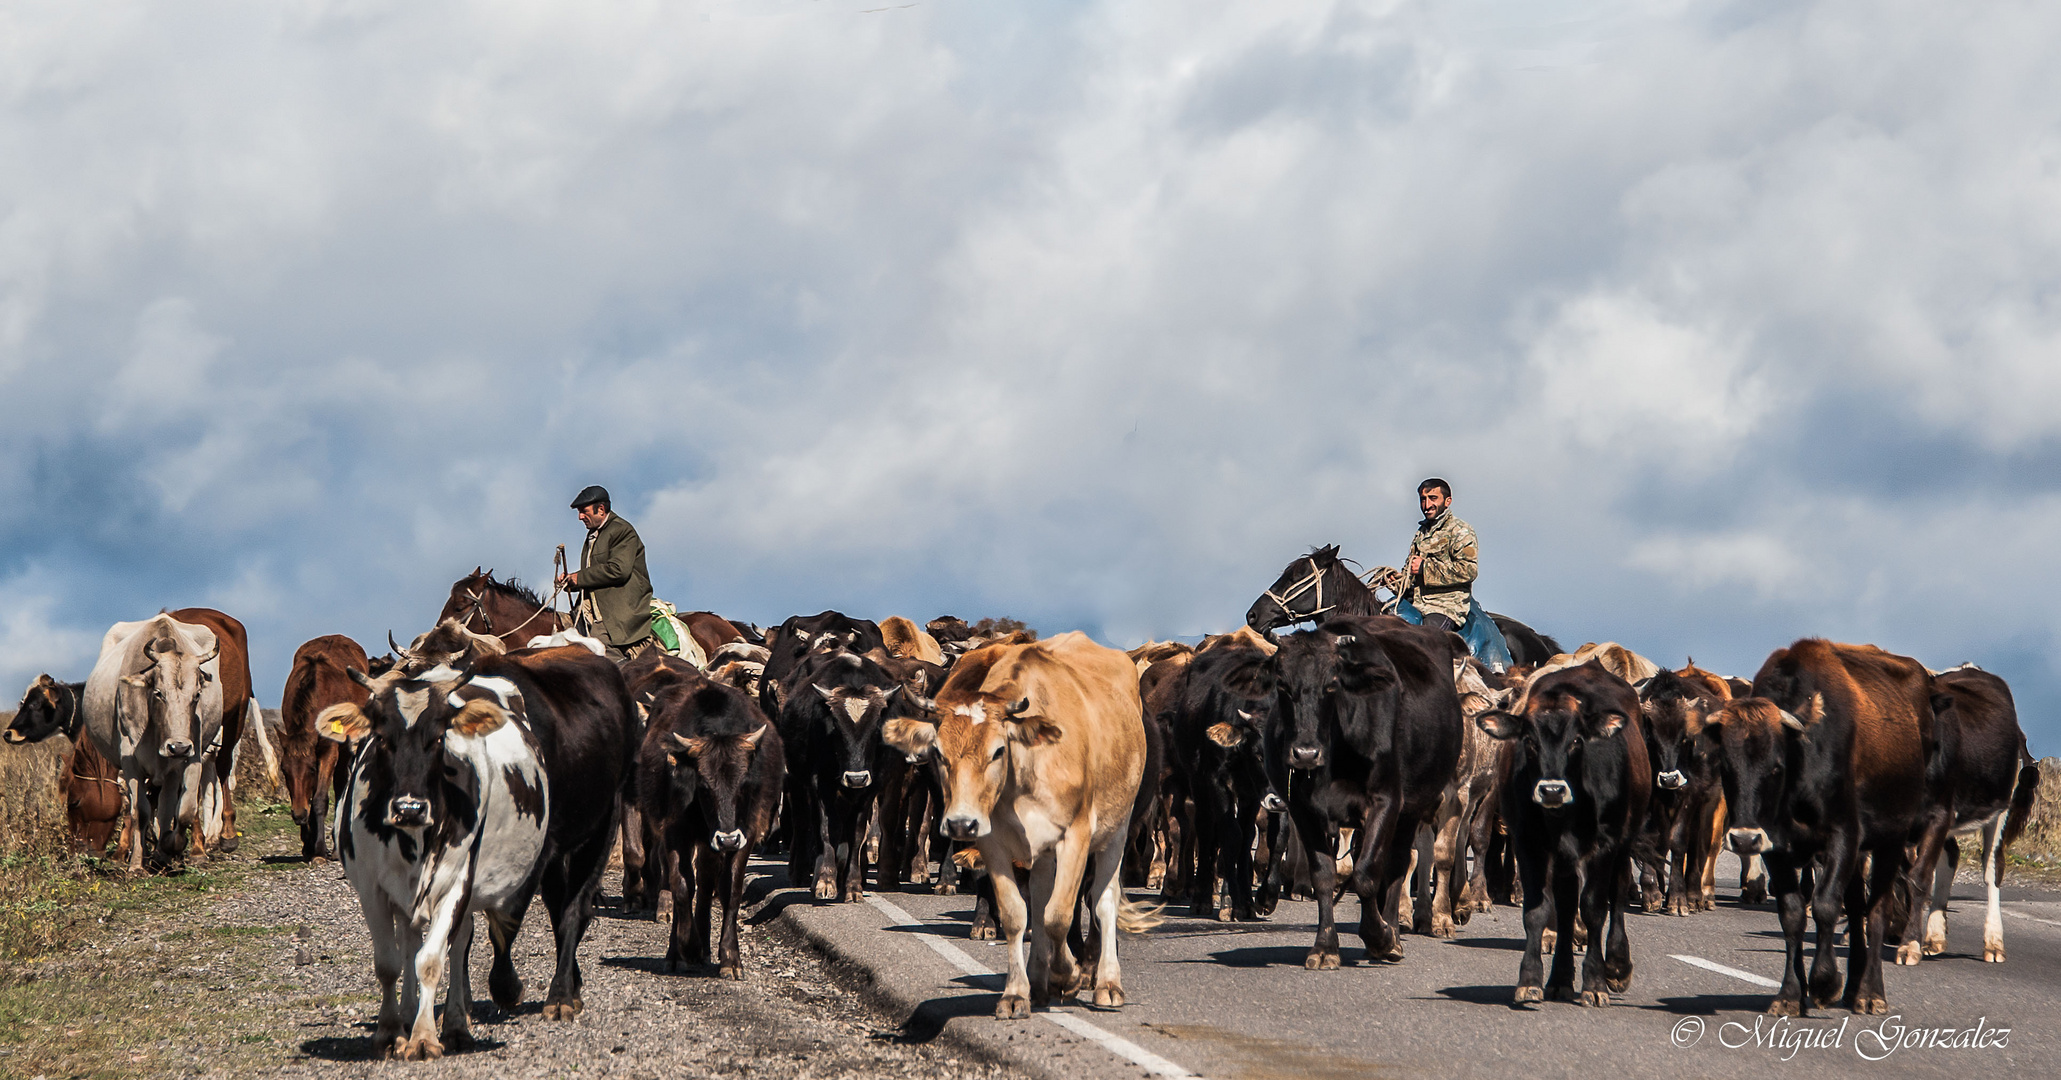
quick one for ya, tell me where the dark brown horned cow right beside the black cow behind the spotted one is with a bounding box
[637,682,785,979]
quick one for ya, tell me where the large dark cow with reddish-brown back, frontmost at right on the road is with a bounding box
[1704,639,1941,1016]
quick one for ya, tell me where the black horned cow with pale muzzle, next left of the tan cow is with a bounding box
[779,651,909,901]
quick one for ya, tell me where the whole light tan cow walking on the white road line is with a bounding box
[882,633,1146,1020]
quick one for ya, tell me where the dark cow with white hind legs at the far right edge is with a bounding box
[1896,664,2040,965]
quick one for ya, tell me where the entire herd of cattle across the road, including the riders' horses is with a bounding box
[6,548,2038,1059]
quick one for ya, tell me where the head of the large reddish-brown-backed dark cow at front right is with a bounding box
[1700,695,1824,855]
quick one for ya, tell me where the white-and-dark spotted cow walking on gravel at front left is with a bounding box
[315,670,552,1059]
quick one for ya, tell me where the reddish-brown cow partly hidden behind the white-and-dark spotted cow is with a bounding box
[278,633,371,859]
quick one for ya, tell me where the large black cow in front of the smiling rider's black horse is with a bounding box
[1228,616,1467,971]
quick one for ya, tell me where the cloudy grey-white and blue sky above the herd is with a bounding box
[0,0,2061,752]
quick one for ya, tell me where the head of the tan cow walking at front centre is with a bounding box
[882,684,1059,841]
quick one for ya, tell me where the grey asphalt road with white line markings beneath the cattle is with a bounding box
[767,853,2061,1080]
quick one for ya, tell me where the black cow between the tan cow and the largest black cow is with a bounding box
[1148,645,1268,921]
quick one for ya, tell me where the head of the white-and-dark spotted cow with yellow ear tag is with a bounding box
[315,668,521,835]
